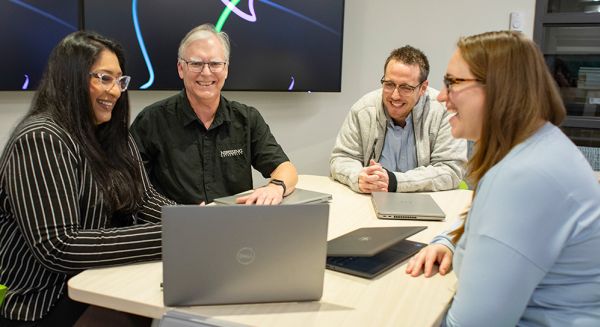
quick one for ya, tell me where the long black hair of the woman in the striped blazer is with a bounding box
[26,31,144,226]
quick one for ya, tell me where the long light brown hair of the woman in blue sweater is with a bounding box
[452,31,566,243]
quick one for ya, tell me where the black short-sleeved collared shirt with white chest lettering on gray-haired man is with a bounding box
[131,90,289,204]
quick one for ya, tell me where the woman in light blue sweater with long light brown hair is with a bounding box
[406,31,600,326]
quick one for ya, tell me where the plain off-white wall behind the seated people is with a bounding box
[0,0,535,183]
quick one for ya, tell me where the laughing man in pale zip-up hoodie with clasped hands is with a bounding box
[329,45,467,193]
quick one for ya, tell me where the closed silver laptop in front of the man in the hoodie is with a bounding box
[371,192,446,221]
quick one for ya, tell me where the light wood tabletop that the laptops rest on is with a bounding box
[69,175,472,326]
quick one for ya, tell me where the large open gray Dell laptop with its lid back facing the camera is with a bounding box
[162,203,329,306]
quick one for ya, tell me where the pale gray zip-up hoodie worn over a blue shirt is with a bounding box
[329,88,467,192]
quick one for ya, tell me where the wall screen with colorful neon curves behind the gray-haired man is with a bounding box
[83,0,344,92]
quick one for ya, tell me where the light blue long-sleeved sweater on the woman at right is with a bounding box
[434,123,600,326]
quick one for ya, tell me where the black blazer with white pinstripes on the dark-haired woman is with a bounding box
[0,116,173,320]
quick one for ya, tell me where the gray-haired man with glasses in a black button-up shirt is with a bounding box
[131,24,298,204]
